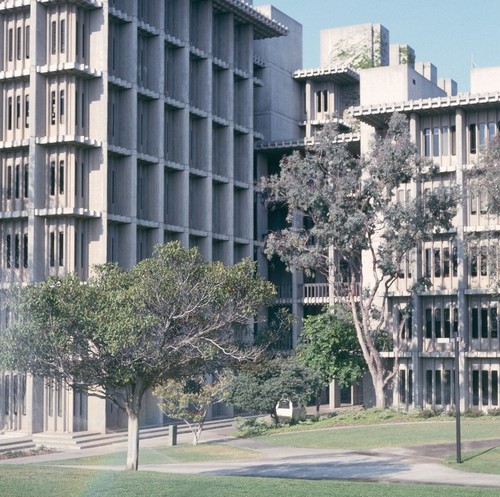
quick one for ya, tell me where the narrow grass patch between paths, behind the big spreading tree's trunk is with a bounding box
[52,443,261,467]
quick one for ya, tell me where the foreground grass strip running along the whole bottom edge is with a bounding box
[0,465,498,497]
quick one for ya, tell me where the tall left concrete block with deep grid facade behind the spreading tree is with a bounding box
[0,0,287,433]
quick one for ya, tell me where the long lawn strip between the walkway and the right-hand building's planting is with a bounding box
[257,417,500,450]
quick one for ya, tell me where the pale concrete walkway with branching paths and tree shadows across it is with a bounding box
[0,420,500,488]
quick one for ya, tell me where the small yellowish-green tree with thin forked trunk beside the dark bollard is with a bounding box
[153,374,231,445]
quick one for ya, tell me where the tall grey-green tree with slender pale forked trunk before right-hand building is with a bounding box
[261,114,457,407]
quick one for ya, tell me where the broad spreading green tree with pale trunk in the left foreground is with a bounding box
[0,243,274,470]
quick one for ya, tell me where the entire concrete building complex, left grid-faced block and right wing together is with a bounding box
[0,0,500,433]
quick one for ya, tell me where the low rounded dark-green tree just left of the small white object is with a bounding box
[225,358,321,424]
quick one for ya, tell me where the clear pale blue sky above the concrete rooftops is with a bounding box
[254,0,500,92]
